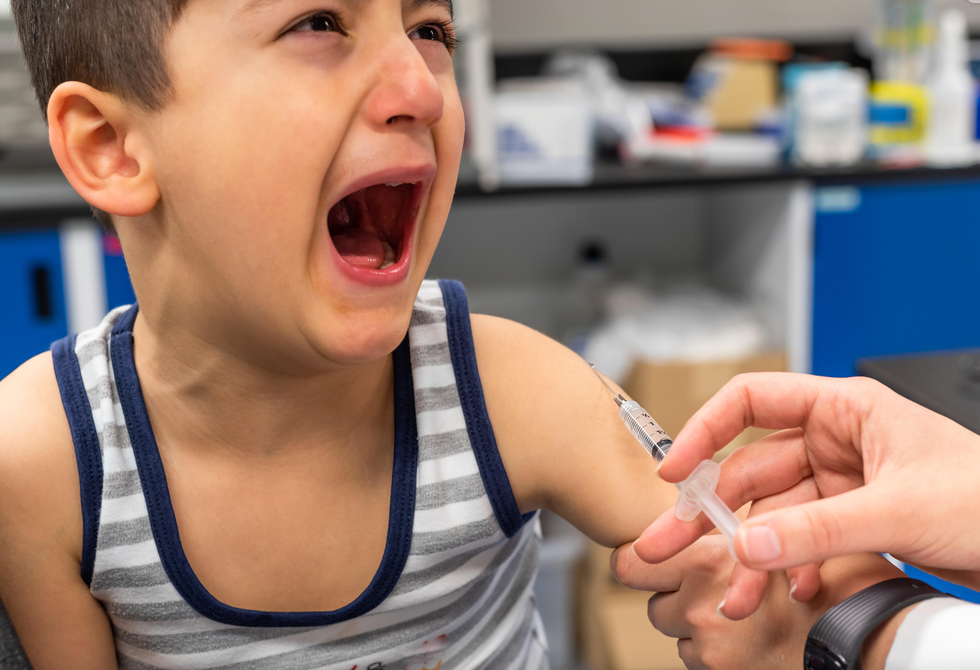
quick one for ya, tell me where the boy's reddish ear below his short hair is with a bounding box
[48,81,160,217]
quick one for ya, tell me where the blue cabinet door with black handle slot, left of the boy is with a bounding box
[0,230,68,378]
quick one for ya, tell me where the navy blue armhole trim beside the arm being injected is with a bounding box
[439,279,534,537]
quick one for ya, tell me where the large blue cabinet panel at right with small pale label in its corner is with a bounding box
[812,181,980,377]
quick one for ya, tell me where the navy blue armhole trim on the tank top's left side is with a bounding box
[51,335,103,586]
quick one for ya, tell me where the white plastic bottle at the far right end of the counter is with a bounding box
[925,9,977,167]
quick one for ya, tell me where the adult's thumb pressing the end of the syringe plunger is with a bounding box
[735,486,901,570]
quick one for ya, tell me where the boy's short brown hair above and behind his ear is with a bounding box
[10,0,187,232]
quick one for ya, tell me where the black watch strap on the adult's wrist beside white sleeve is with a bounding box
[803,577,946,670]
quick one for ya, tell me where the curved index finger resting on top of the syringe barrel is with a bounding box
[660,372,832,483]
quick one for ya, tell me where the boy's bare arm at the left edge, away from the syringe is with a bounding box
[0,354,116,670]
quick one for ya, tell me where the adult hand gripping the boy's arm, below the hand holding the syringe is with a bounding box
[611,535,901,670]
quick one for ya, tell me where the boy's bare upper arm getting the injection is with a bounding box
[471,315,677,547]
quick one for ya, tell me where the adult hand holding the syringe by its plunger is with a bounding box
[634,373,980,600]
